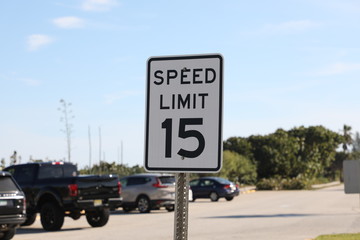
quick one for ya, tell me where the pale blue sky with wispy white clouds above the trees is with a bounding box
[0,0,360,169]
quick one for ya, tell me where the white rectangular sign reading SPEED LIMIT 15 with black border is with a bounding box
[145,54,223,172]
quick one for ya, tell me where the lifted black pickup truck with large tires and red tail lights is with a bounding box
[4,162,121,231]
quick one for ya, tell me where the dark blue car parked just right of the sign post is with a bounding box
[190,177,240,202]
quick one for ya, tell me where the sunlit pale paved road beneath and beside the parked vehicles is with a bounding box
[14,185,360,240]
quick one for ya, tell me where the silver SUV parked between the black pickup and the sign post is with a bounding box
[120,173,175,213]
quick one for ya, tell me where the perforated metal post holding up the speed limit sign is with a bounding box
[174,173,189,240]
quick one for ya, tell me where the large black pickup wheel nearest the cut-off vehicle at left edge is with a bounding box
[40,203,64,231]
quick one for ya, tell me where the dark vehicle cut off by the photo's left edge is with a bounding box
[0,171,26,240]
